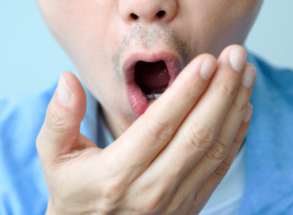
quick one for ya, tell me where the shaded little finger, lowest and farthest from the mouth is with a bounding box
[188,109,252,215]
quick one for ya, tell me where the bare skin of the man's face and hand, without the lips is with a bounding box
[37,0,262,215]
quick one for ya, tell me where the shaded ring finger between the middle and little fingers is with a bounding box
[177,64,256,190]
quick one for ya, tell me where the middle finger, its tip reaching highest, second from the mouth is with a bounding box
[141,46,246,189]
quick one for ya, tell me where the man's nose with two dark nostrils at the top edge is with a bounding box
[118,0,178,23]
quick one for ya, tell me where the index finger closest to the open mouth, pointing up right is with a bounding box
[103,55,217,180]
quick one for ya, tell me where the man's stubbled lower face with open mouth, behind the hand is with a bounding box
[38,0,262,133]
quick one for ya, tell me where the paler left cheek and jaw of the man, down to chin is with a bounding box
[39,0,133,116]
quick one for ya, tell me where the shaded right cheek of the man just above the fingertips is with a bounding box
[182,0,262,56]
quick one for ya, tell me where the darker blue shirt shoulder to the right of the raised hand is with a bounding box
[239,51,293,214]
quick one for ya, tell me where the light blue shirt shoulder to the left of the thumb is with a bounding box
[0,84,57,214]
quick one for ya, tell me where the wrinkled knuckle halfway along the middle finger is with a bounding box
[183,122,214,150]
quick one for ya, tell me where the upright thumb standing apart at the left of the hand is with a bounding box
[37,72,86,162]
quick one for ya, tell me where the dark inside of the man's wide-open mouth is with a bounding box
[134,61,170,95]
